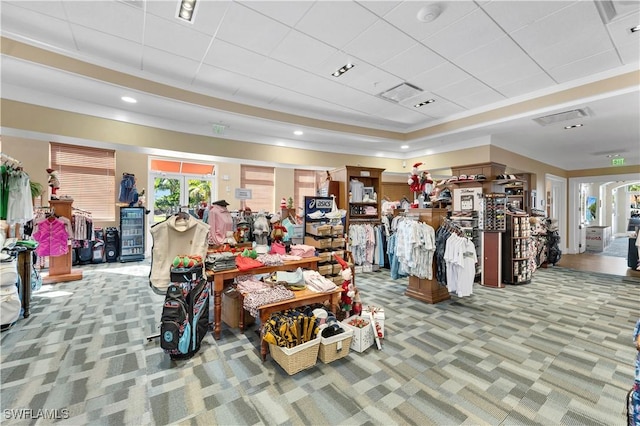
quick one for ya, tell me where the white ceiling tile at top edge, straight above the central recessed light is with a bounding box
[296,1,378,49]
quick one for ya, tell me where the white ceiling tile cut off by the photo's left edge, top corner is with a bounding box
[0,3,76,52]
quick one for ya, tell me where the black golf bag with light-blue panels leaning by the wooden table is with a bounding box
[160,264,209,359]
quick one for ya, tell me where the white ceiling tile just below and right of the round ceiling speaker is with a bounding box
[423,9,504,60]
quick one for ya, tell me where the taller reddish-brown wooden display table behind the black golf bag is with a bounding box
[207,257,320,340]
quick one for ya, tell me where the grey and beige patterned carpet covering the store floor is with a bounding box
[0,263,640,425]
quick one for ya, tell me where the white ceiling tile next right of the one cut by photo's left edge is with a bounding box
[71,24,142,70]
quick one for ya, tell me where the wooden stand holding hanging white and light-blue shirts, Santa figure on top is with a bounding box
[404,209,451,304]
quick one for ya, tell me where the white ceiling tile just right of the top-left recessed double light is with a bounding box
[217,2,289,55]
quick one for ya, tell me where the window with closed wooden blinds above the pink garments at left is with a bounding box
[50,142,116,221]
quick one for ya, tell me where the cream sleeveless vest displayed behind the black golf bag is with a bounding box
[149,214,209,294]
